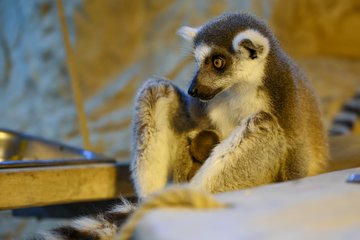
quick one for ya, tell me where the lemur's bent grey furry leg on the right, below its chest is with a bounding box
[190,112,287,193]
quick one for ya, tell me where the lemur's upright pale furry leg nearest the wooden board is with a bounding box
[131,79,189,198]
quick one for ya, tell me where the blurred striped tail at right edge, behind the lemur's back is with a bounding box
[329,89,360,136]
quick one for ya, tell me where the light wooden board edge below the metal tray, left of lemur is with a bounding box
[0,163,133,210]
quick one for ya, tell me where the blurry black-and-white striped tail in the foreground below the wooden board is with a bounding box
[31,200,136,240]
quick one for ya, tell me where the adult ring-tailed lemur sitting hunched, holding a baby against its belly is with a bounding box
[33,13,327,239]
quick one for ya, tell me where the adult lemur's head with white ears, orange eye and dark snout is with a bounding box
[178,13,272,101]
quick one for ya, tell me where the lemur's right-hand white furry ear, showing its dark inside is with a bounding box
[233,29,270,59]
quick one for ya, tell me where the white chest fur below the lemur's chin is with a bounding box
[208,86,268,139]
